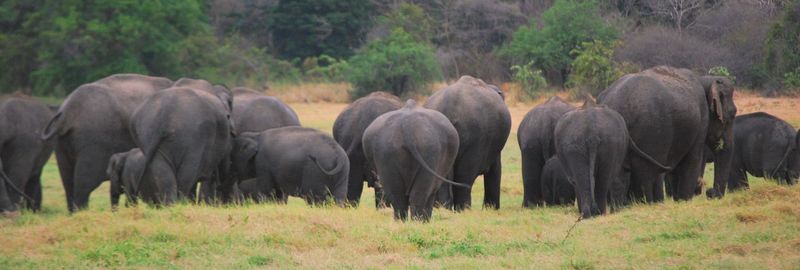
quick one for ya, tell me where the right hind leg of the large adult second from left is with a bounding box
[71,150,111,212]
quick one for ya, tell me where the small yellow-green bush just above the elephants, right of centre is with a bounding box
[568,40,625,98]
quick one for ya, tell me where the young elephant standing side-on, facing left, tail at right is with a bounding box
[231,126,350,205]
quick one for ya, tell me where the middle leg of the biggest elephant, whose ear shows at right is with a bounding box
[672,145,705,201]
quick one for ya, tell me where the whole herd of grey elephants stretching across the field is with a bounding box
[0,66,800,221]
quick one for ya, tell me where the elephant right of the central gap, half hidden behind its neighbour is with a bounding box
[517,96,575,207]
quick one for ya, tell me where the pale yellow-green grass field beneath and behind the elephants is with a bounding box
[0,91,800,269]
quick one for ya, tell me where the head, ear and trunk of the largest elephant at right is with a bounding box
[700,76,736,198]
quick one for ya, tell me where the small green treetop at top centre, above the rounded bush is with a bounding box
[379,3,434,43]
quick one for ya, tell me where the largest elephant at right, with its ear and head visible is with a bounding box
[598,66,736,202]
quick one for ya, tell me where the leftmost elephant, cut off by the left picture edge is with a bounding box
[0,95,53,216]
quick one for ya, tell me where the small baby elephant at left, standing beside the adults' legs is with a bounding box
[106,148,178,209]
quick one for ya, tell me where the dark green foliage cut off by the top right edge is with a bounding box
[764,0,800,89]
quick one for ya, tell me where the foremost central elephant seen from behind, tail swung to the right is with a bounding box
[363,99,462,222]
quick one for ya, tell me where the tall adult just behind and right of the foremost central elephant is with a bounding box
[424,76,511,211]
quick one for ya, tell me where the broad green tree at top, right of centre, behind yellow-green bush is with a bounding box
[498,0,619,83]
